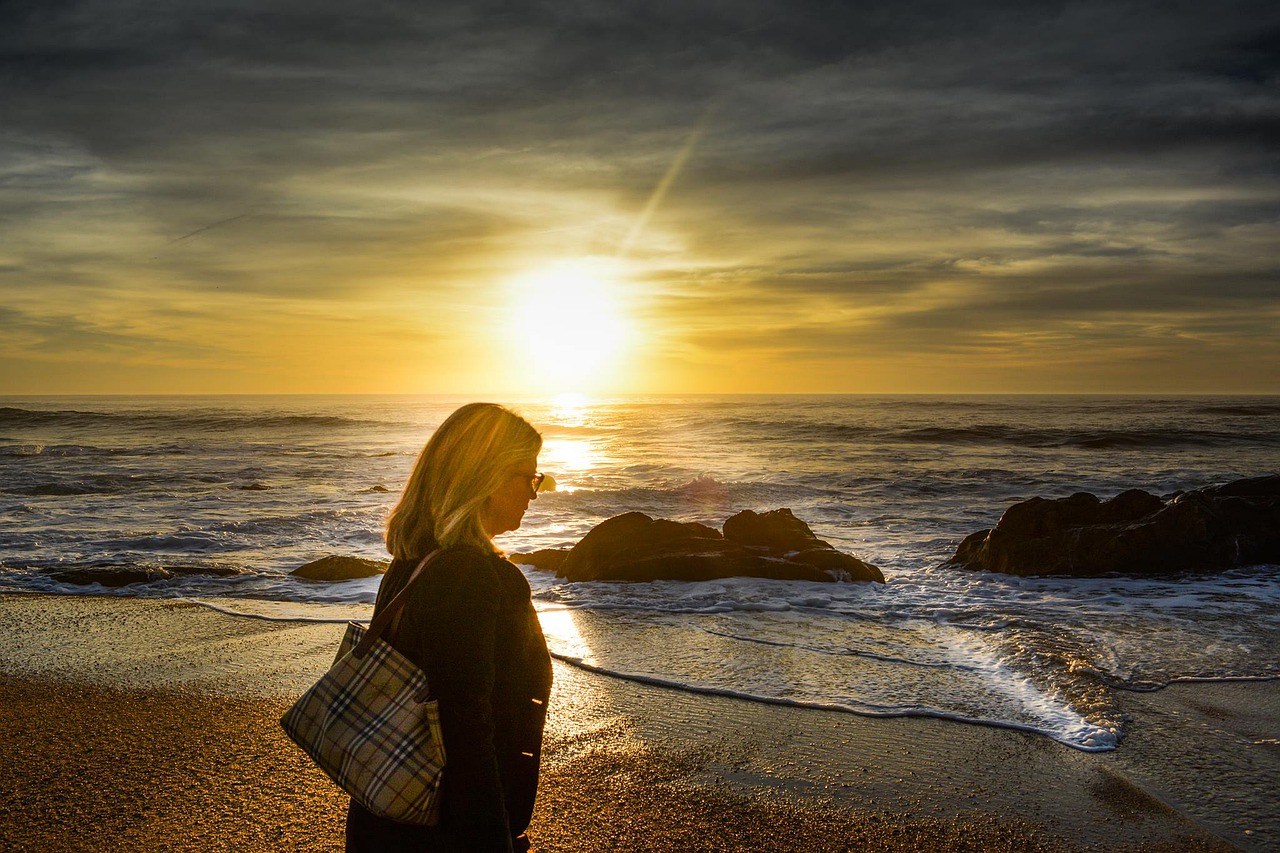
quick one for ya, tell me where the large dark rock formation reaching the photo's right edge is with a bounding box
[946,476,1280,578]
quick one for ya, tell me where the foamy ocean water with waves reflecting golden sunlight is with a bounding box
[0,396,1280,751]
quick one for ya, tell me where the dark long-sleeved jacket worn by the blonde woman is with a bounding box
[347,546,552,853]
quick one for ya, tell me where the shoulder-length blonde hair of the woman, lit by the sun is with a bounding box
[387,403,543,560]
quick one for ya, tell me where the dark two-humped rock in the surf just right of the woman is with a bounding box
[556,510,884,583]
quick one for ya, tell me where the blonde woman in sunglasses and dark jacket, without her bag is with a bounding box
[347,403,552,853]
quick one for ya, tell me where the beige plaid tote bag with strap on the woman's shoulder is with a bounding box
[280,551,444,826]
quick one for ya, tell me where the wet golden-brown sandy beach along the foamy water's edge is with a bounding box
[0,594,1280,852]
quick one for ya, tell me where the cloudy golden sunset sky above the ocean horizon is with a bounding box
[0,0,1280,394]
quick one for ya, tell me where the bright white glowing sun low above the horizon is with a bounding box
[509,259,632,393]
